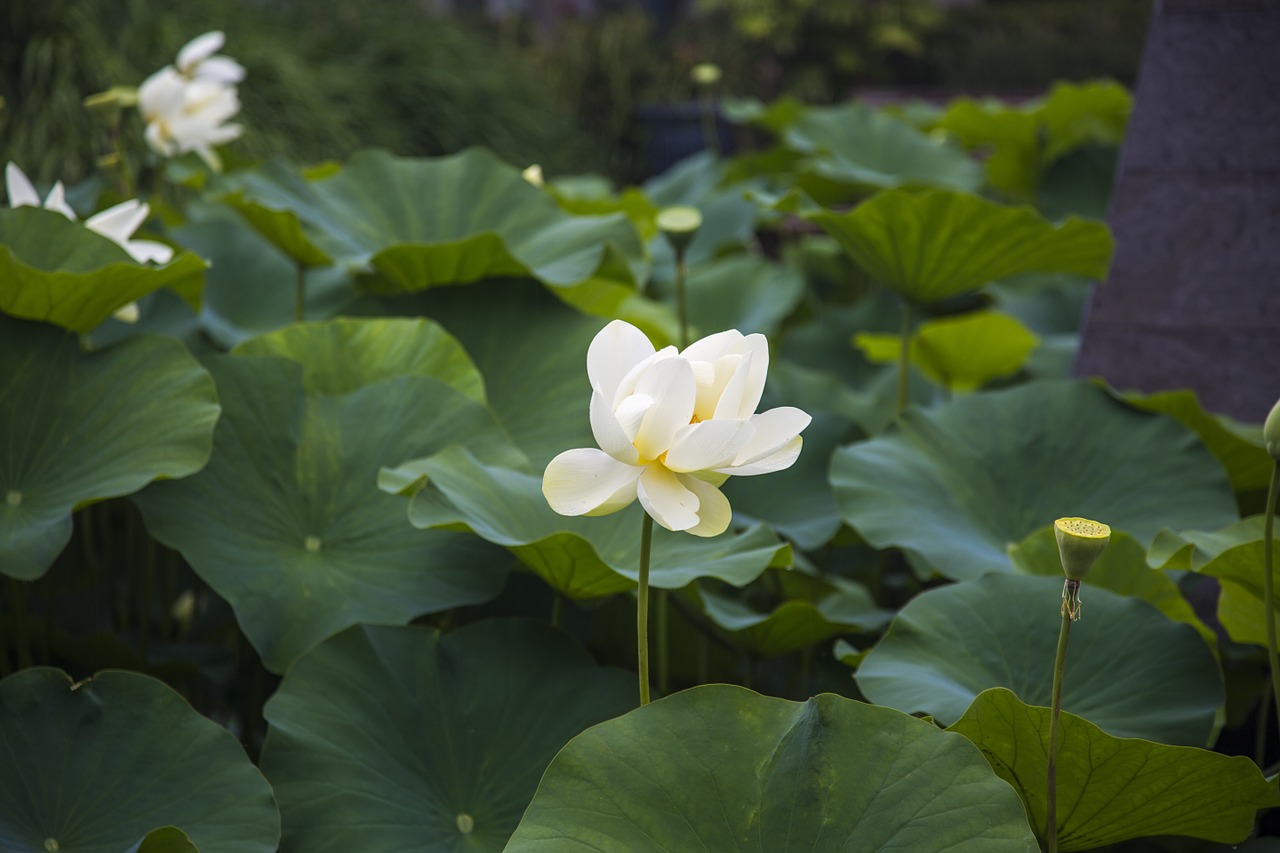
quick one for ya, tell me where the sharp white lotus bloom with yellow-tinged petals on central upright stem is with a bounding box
[543,320,810,537]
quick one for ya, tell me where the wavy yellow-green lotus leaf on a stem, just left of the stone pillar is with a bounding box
[810,190,1112,302]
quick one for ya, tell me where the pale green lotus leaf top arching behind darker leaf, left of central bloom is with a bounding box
[236,318,485,403]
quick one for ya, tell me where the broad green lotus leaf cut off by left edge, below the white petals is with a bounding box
[0,313,219,580]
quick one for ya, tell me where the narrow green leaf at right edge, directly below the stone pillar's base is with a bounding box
[1111,389,1271,494]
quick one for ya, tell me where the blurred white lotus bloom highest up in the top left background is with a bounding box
[138,32,244,172]
